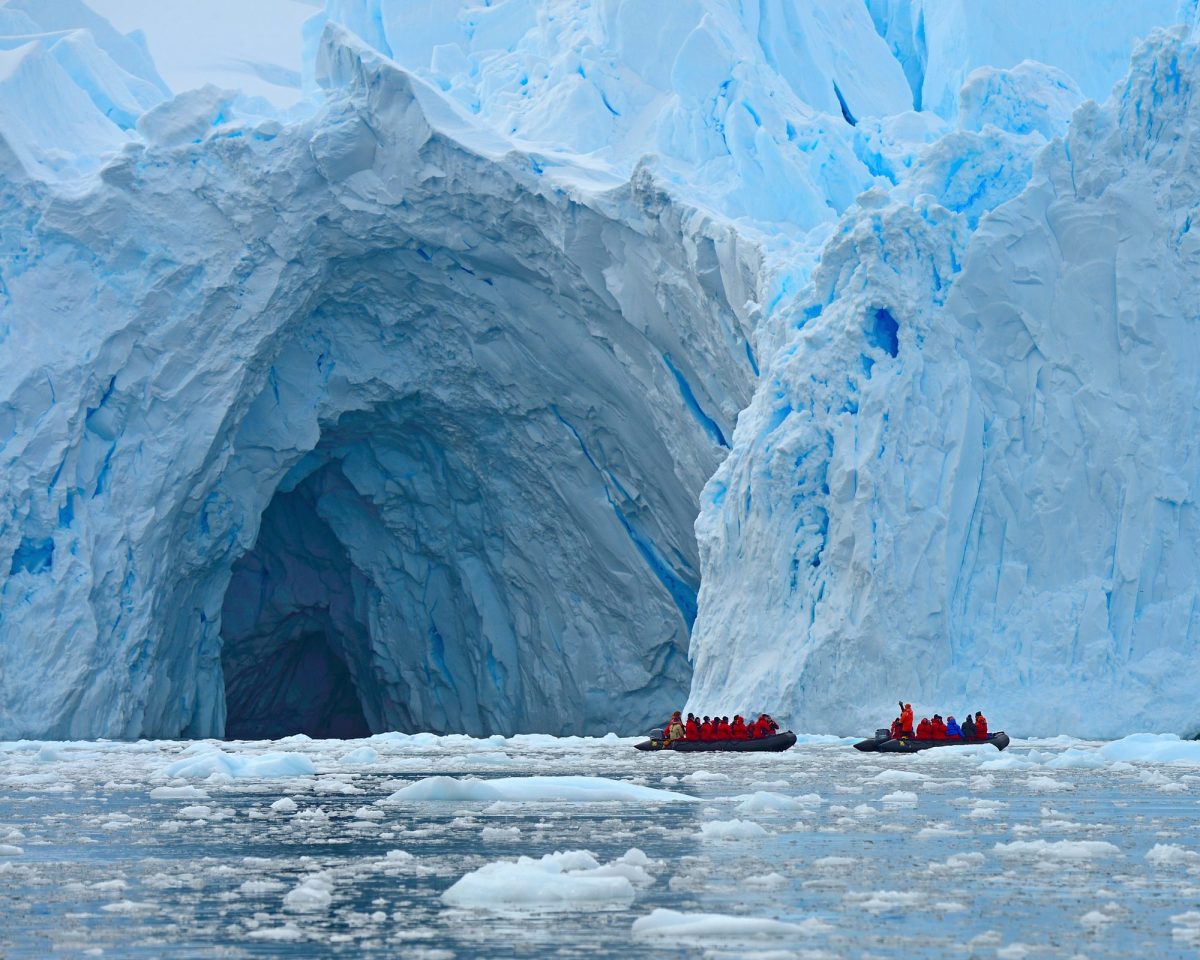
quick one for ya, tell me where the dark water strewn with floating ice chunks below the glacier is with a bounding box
[0,736,1200,960]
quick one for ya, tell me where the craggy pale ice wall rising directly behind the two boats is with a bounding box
[691,30,1200,736]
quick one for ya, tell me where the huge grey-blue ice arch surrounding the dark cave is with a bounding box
[0,30,757,737]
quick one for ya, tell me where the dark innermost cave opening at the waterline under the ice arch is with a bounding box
[221,461,372,739]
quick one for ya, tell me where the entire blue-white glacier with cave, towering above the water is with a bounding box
[0,0,1200,738]
